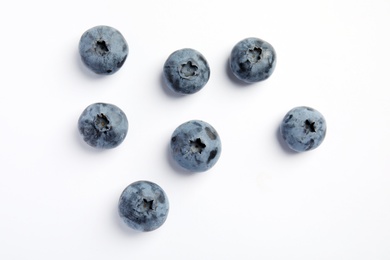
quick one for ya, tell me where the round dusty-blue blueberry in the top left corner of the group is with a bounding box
[79,25,129,75]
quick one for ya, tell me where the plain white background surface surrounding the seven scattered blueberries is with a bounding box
[0,0,390,260]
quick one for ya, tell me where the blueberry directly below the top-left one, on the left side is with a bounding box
[78,103,128,149]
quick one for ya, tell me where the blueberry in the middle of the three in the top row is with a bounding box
[163,48,210,95]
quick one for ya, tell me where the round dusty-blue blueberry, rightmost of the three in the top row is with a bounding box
[229,37,276,83]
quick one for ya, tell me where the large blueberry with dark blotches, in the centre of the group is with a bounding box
[170,120,221,172]
